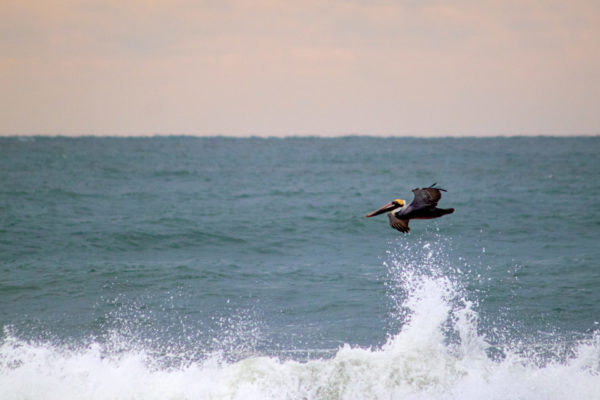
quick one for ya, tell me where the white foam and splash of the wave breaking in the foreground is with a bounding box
[0,239,600,400]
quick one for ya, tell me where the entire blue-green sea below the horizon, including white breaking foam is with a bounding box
[0,137,600,400]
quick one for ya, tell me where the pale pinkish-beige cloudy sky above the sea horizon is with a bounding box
[0,0,600,136]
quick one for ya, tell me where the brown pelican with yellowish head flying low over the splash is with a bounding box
[367,183,454,232]
